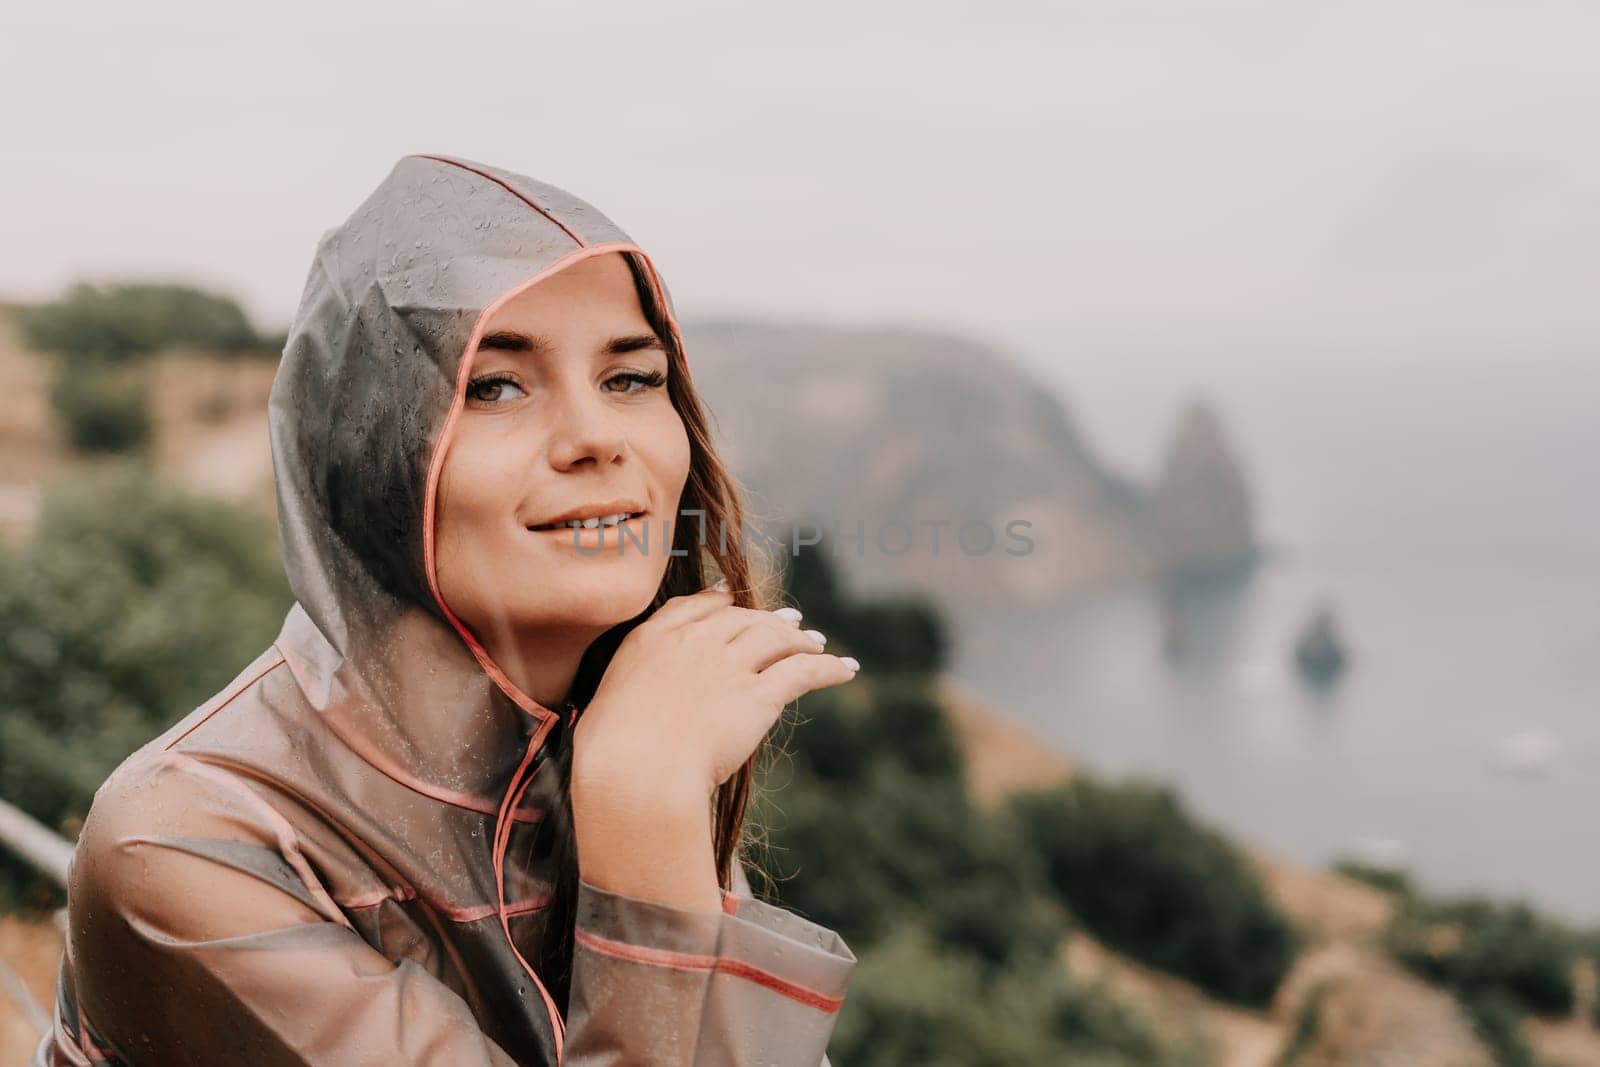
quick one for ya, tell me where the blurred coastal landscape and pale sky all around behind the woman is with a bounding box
[0,0,1600,1067]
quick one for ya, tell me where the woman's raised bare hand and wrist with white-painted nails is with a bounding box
[571,589,856,909]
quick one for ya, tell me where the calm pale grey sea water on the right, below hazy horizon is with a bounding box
[955,347,1600,921]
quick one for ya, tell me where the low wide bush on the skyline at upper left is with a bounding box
[21,283,272,363]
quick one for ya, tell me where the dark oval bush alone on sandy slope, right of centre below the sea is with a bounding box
[1008,777,1294,1005]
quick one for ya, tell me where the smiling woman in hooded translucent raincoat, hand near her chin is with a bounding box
[37,155,856,1067]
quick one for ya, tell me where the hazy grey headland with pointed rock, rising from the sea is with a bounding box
[685,322,1254,608]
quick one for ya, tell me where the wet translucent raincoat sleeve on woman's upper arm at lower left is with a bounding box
[58,753,515,1067]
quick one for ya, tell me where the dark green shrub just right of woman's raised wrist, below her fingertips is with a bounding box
[754,672,1067,969]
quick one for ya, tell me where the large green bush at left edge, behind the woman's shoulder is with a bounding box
[0,461,291,837]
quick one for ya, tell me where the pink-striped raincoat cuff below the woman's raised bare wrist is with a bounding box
[563,864,856,1067]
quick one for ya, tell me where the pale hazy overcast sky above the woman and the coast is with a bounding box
[0,0,1600,476]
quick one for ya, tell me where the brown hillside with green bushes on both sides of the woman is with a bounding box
[0,292,1600,1067]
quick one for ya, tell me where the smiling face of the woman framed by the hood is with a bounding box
[435,253,690,643]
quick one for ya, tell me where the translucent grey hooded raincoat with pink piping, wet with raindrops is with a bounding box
[35,155,856,1067]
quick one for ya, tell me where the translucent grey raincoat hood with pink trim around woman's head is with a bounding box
[270,155,694,1036]
